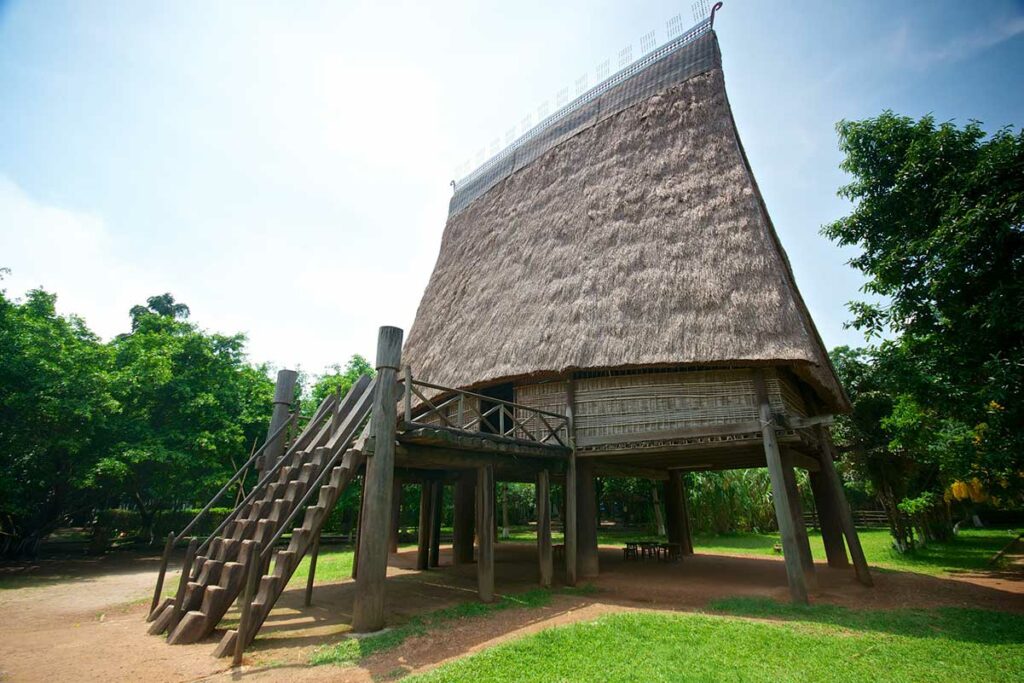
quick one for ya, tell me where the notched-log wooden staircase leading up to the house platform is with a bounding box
[148,377,376,654]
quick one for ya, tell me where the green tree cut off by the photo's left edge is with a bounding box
[0,290,119,554]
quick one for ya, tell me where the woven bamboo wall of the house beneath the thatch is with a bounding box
[516,369,807,443]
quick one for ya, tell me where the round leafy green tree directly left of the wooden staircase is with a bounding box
[90,295,273,540]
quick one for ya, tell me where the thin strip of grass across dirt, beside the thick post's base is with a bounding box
[309,587,593,666]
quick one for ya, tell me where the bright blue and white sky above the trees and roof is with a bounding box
[0,0,1024,374]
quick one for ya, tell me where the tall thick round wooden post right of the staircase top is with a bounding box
[352,327,402,633]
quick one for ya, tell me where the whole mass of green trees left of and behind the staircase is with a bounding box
[0,282,352,554]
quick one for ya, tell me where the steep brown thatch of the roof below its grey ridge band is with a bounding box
[403,29,848,410]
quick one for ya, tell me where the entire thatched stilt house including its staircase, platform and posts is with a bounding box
[142,12,870,664]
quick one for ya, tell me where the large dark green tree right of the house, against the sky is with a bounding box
[823,112,1024,548]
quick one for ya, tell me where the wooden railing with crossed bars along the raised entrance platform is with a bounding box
[399,366,569,447]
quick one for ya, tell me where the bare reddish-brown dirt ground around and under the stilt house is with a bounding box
[0,544,1024,682]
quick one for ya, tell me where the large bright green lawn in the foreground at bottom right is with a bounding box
[406,600,1024,683]
